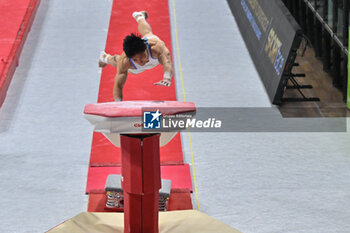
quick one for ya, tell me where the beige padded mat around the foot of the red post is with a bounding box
[48,210,240,233]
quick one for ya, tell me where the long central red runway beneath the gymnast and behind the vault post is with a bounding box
[86,0,192,211]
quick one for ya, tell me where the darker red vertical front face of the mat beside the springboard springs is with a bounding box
[87,189,193,212]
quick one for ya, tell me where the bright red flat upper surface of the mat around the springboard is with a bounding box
[86,164,192,193]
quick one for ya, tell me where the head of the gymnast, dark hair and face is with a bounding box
[123,33,149,65]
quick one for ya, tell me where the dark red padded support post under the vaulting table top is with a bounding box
[120,134,161,233]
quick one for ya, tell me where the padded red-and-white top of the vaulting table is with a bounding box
[84,101,196,147]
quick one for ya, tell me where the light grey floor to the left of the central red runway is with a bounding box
[0,0,112,233]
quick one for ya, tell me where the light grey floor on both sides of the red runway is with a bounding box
[0,0,350,233]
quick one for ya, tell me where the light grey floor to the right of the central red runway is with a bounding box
[169,0,350,233]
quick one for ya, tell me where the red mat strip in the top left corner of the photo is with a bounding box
[0,0,40,107]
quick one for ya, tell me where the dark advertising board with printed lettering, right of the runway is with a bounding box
[227,0,302,104]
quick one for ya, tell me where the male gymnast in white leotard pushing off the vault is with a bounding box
[98,11,174,101]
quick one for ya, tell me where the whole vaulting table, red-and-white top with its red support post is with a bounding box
[84,101,196,233]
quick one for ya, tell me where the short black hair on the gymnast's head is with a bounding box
[123,33,146,58]
